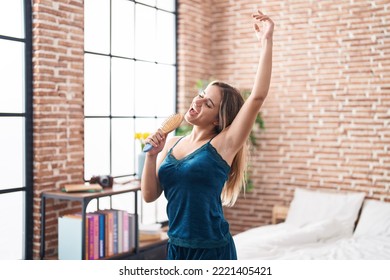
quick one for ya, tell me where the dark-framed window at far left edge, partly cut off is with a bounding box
[0,0,32,260]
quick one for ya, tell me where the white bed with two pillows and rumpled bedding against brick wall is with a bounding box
[233,189,390,260]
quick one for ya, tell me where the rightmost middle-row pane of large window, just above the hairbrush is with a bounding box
[153,64,176,116]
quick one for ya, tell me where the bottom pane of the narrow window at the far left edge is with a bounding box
[0,191,25,260]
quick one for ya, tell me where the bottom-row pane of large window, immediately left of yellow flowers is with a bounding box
[112,119,134,176]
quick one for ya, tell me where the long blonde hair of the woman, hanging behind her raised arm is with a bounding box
[210,81,248,207]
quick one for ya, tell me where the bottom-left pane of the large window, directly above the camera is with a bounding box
[84,119,110,180]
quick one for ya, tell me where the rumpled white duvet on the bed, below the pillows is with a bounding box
[233,223,390,260]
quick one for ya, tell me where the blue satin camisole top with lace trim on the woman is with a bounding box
[158,137,230,248]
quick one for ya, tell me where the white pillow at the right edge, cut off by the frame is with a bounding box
[353,200,390,236]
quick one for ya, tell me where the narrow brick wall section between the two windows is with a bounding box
[32,0,84,259]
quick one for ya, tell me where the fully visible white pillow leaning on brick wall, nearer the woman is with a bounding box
[286,188,365,235]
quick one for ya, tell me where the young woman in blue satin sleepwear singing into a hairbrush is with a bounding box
[141,11,274,260]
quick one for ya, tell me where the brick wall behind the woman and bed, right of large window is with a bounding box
[178,0,390,233]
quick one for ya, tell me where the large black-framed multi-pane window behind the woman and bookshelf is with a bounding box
[84,0,176,224]
